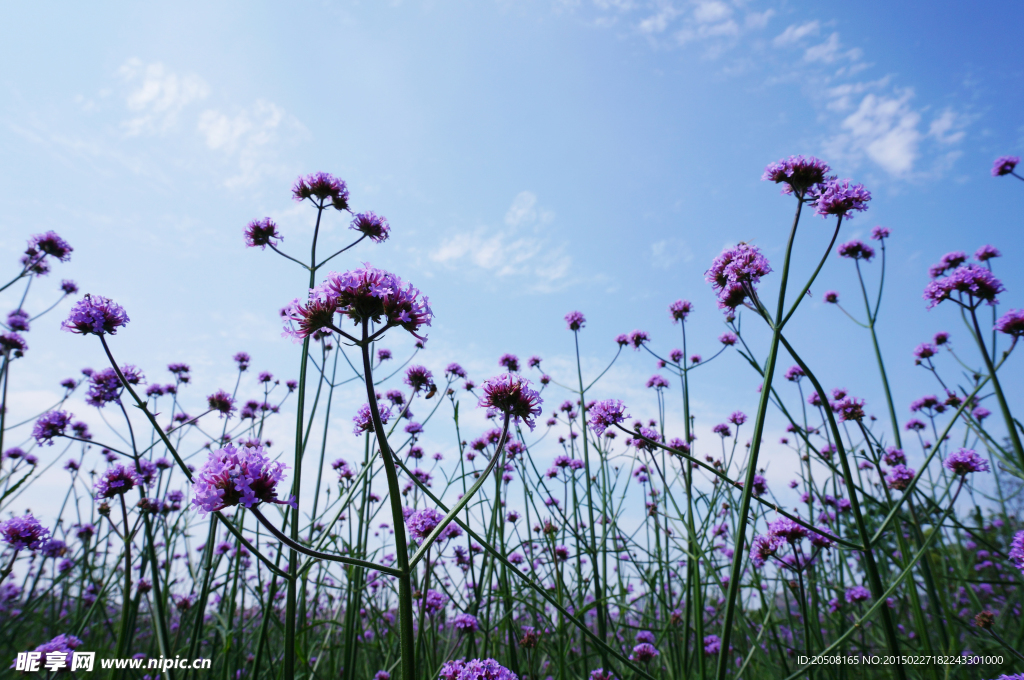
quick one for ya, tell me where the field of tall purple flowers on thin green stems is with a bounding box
[0,157,1024,680]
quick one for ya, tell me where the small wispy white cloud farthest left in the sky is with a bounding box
[118,58,210,136]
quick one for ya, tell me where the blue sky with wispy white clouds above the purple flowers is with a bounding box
[0,0,1024,503]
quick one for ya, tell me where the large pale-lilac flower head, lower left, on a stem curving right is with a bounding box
[193,444,294,515]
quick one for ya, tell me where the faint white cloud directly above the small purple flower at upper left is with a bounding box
[198,99,305,187]
